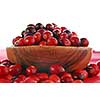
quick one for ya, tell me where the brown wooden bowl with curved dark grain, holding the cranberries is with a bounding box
[6,46,92,72]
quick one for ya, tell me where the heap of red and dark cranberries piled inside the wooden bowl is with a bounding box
[12,23,89,47]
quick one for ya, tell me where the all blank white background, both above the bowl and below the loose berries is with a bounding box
[0,0,100,100]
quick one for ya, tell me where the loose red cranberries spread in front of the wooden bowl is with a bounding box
[0,60,100,83]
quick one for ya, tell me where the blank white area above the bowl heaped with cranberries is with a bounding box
[0,0,100,50]
